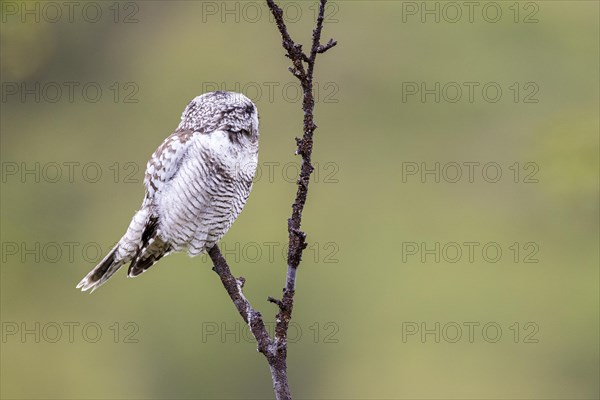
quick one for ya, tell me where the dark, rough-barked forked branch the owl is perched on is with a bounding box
[208,0,337,399]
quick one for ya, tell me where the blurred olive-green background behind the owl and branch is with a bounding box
[0,1,600,399]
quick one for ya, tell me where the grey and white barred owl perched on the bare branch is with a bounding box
[77,92,258,291]
